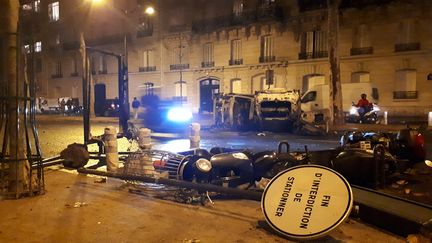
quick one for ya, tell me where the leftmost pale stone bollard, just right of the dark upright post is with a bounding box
[103,126,119,172]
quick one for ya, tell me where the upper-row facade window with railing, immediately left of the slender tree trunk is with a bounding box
[299,30,328,59]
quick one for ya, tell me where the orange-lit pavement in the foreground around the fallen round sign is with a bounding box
[0,167,404,242]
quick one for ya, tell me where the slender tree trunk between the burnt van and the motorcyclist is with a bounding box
[327,0,345,125]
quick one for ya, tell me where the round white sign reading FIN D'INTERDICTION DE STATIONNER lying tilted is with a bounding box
[261,165,353,240]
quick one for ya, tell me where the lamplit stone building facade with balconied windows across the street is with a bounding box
[5,0,432,116]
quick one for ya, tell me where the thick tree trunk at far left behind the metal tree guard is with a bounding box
[0,0,31,198]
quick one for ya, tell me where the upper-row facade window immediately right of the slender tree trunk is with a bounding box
[351,24,373,55]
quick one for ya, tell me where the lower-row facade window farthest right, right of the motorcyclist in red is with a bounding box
[393,69,418,99]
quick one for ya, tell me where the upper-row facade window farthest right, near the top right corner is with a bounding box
[395,19,420,52]
